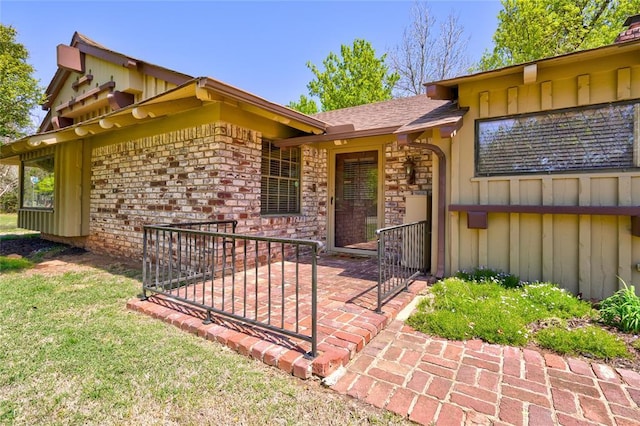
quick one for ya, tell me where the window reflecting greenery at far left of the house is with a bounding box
[22,156,55,209]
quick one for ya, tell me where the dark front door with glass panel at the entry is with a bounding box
[334,151,378,251]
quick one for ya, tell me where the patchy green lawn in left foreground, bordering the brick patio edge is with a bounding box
[0,269,405,425]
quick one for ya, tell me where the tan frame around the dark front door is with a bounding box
[327,142,385,256]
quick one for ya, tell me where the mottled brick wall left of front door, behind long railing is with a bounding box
[87,123,327,258]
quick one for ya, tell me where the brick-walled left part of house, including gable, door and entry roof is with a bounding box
[0,33,450,270]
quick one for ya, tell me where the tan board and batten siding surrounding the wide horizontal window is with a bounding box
[448,53,640,299]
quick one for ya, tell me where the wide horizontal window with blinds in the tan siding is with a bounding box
[476,103,640,176]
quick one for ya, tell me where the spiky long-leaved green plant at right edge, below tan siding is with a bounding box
[599,279,640,333]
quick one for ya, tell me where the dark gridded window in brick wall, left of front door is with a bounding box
[260,140,301,214]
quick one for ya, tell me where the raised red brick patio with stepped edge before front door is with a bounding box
[127,251,427,379]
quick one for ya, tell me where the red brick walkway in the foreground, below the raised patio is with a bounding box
[332,321,640,426]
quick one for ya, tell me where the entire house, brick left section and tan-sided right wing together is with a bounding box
[0,20,640,299]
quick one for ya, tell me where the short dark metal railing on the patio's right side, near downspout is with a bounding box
[376,221,430,313]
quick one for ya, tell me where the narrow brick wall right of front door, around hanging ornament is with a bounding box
[384,142,433,226]
